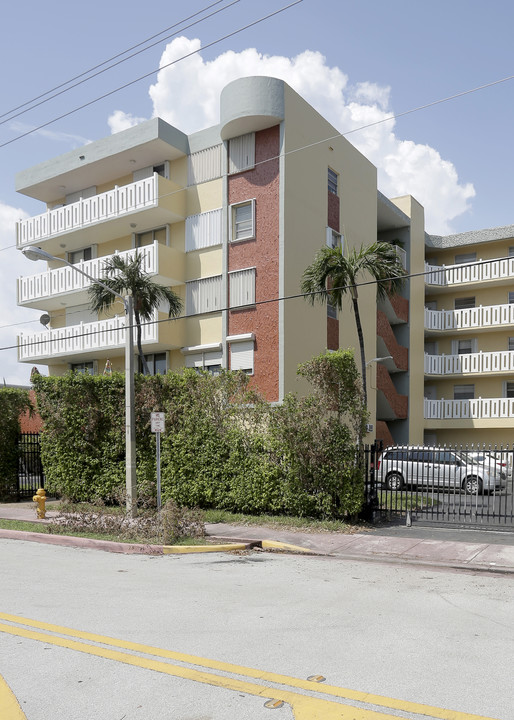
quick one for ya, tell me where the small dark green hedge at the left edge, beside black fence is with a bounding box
[0,387,33,499]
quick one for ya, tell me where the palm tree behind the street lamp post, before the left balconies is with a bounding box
[88,252,182,375]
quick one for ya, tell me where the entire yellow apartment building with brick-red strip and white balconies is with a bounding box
[16,77,514,450]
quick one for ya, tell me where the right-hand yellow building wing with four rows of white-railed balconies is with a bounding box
[424,225,514,446]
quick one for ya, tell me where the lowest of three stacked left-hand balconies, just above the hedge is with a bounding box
[18,312,184,365]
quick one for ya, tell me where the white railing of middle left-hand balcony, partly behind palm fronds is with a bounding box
[18,241,159,305]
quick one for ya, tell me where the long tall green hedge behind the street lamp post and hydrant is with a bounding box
[34,351,365,518]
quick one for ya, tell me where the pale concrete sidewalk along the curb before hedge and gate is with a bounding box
[0,502,514,574]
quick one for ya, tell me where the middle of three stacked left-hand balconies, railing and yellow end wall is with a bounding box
[18,241,185,310]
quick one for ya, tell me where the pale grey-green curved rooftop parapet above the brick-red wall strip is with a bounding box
[220,76,285,140]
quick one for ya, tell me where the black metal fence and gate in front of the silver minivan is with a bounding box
[365,444,514,529]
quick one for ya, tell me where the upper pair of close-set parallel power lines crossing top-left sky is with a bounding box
[0,0,240,125]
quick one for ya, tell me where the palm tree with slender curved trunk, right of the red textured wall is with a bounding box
[302,242,406,406]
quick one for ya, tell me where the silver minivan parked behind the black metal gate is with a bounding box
[377,445,501,495]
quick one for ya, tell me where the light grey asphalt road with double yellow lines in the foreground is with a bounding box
[0,540,514,720]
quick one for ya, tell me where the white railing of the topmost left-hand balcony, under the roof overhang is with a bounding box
[17,173,159,247]
